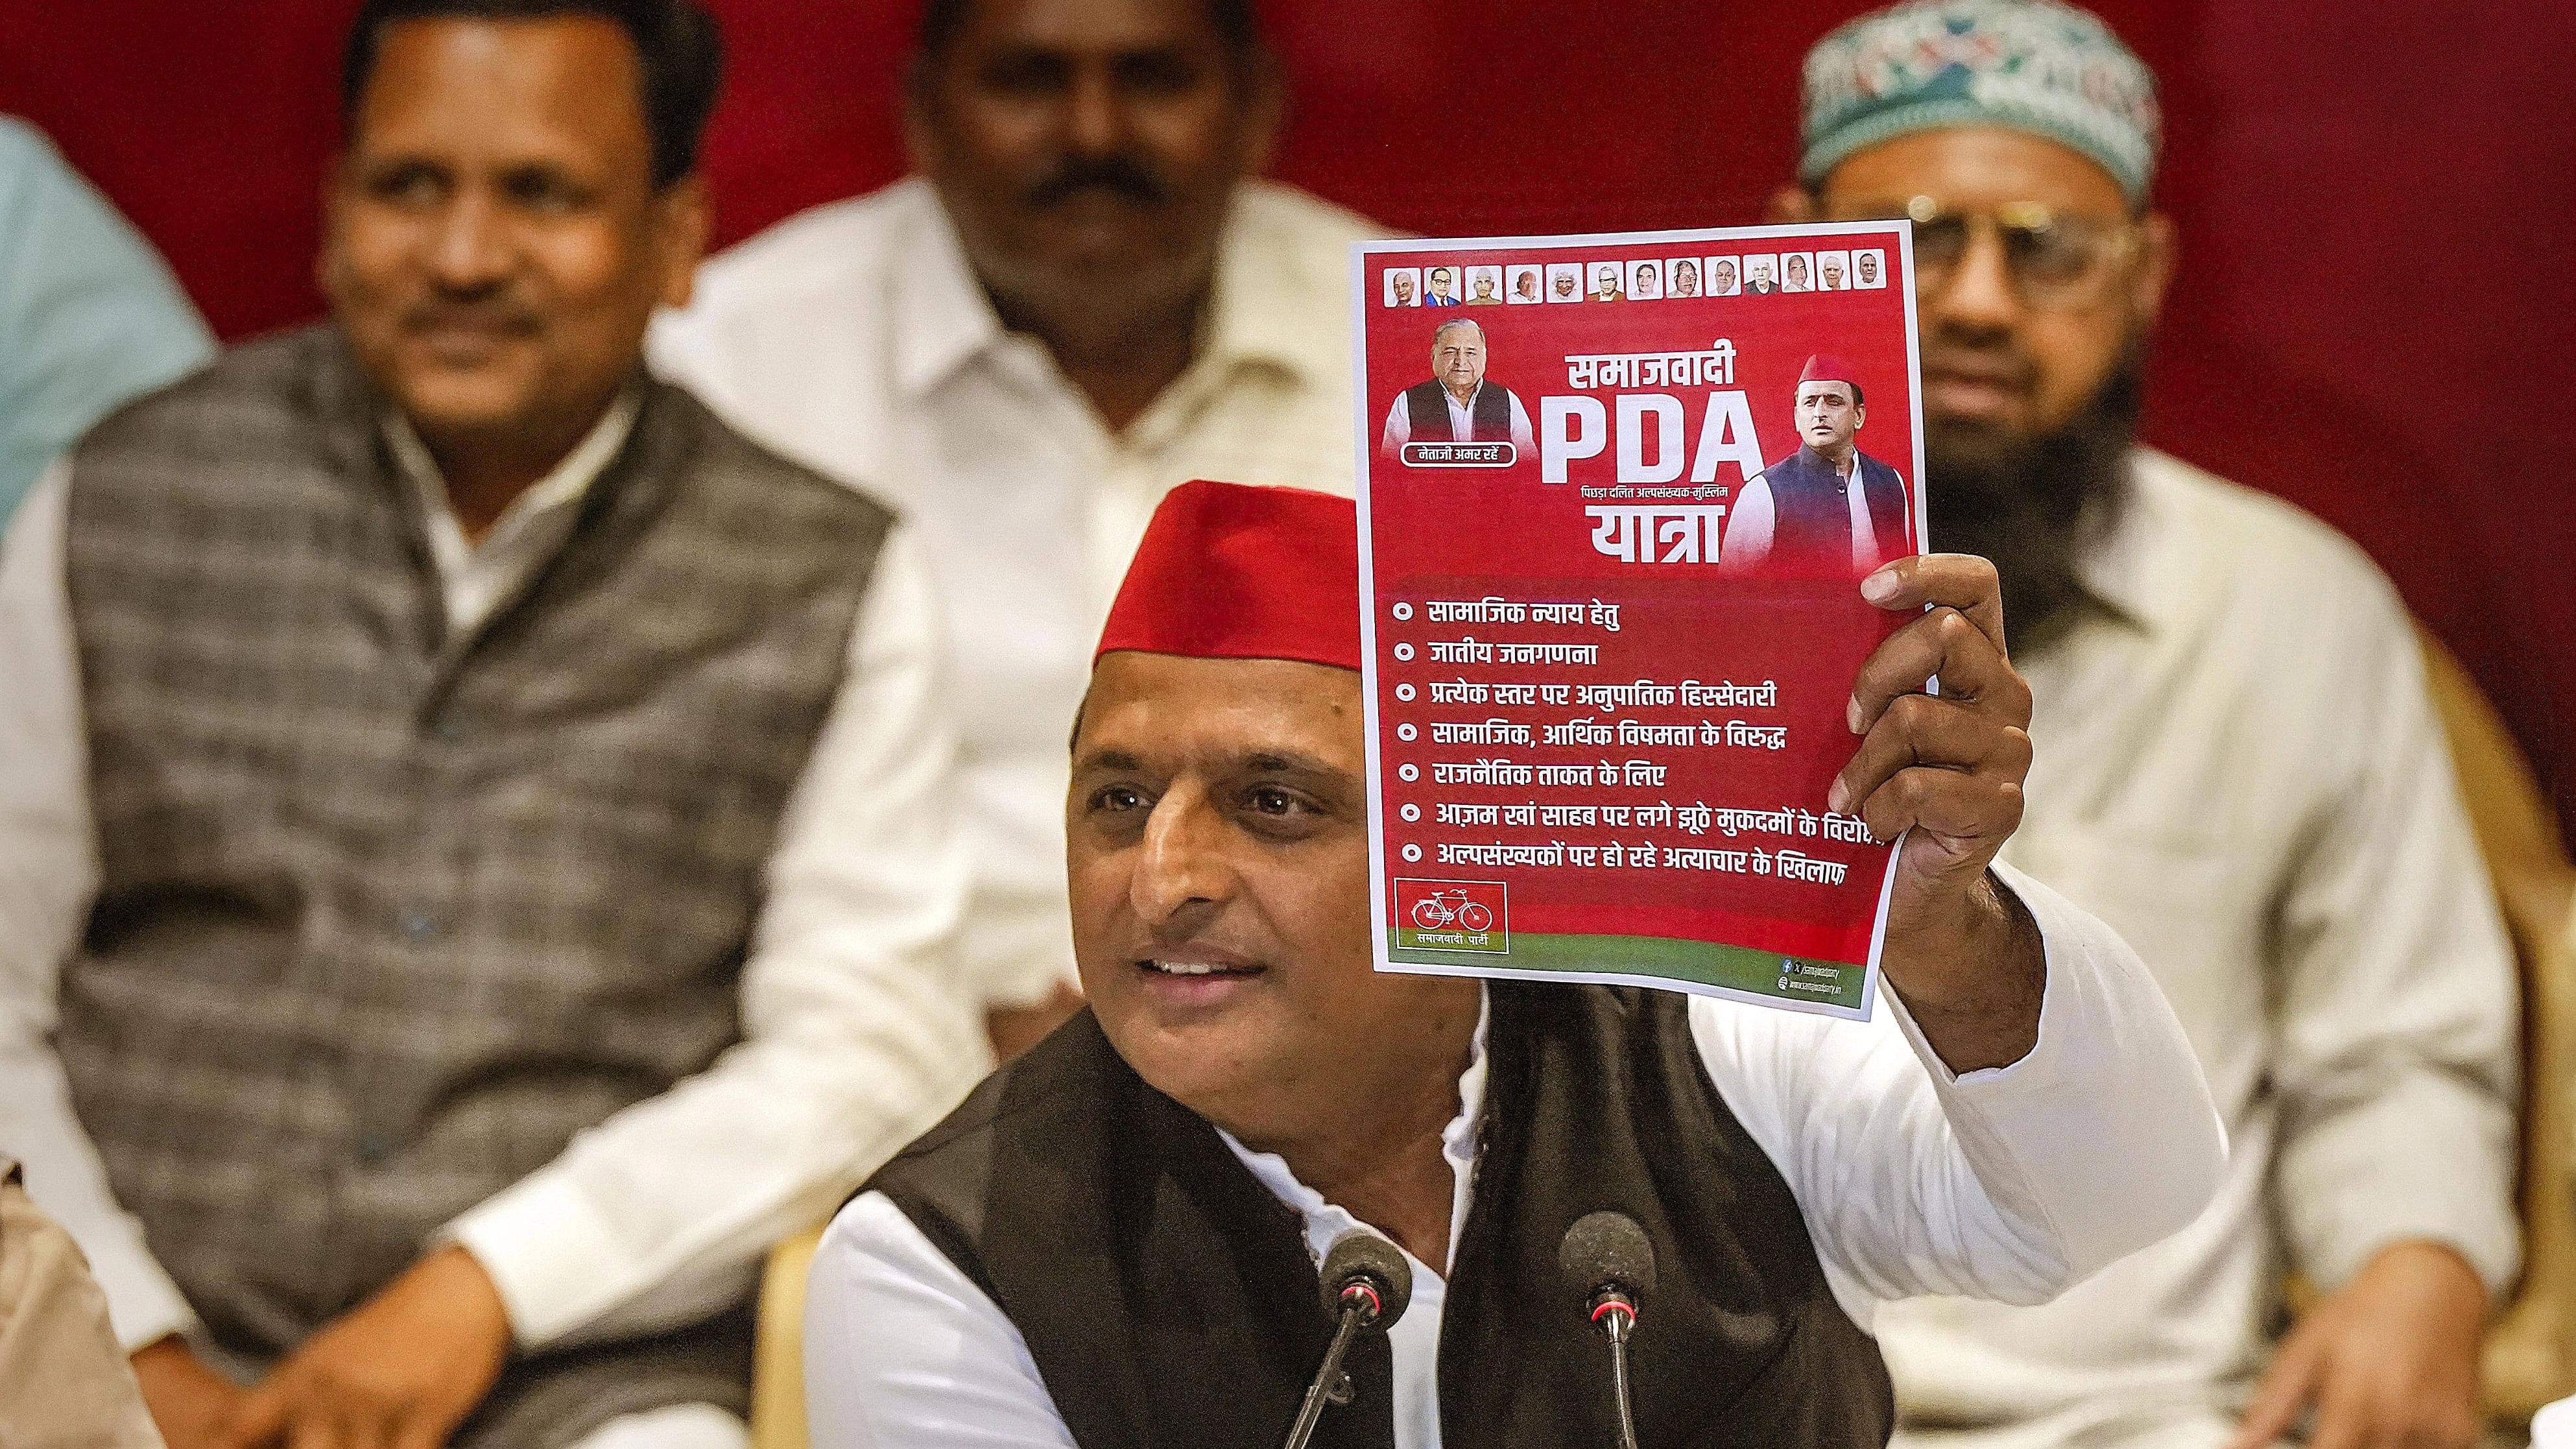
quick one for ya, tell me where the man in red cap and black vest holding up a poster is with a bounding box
[806,482,2226,1449]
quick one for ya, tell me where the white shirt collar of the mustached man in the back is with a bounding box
[888,175,1350,410]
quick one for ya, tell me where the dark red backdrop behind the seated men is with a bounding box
[0,0,2576,822]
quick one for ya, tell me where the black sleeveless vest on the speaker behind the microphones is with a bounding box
[868,983,1893,1449]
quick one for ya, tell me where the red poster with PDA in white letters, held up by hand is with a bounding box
[1352,222,1924,1018]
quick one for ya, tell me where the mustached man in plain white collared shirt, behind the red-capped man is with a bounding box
[654,0,1401,1039]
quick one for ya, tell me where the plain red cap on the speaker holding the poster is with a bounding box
[1092,479,1360,671]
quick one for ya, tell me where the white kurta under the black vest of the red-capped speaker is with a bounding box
[806,872,2226,1449]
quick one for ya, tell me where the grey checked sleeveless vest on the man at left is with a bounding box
[56,328,888,1449]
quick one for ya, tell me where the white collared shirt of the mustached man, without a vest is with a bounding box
[652,180,1378,1003]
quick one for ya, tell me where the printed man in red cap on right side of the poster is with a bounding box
[1718,353,1914,577]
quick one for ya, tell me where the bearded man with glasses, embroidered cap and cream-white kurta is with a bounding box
[1780,0,2517,1449]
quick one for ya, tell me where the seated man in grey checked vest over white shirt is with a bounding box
[0,0,986,1449]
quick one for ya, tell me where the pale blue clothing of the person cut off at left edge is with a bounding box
[0,116,214,529]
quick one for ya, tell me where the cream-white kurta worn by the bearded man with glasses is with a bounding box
[1878,451,2517,1449]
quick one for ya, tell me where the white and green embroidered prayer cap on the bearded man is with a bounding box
[1798,0,2162,206]
